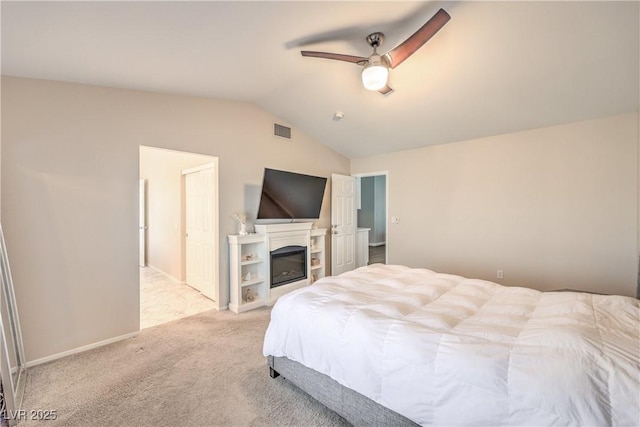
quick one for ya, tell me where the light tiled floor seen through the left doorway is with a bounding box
[140,267,215,329]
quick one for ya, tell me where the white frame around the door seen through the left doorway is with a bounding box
[181,157,222,304]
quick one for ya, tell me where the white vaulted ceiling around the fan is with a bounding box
[1,1,640,158]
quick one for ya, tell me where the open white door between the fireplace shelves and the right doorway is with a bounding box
[331,174,356,276]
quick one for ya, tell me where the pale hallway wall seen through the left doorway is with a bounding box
[140,146,215,282]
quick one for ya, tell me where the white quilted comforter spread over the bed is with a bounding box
[264,264,640,426]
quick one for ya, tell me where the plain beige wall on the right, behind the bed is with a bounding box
[351,113,639,296]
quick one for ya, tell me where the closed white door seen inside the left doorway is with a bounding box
[183,163,218,301]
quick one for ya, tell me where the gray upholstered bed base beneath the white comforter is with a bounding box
[268,356,417,427]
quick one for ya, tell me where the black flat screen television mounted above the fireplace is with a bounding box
[257,168,327,220]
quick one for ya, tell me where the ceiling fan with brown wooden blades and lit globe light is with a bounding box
[300,9,451,95]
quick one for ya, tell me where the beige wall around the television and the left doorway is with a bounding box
[1,77,349,361]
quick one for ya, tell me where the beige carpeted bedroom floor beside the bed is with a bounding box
[19,308,348,427]
